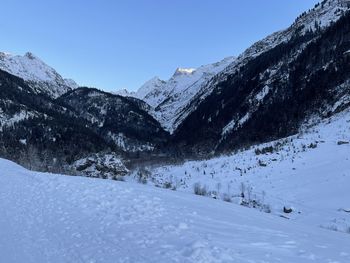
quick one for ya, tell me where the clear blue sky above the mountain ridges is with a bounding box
[0,0,318,91]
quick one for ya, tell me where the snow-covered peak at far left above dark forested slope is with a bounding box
[0,52,78,98]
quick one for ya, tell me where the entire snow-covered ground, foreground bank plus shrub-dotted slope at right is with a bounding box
[0,107,350,263]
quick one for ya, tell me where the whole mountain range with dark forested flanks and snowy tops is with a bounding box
[0,0,350,177]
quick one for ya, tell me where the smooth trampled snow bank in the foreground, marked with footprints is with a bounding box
[0,159,350,263]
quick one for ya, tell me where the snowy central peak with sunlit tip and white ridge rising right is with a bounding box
[117,0,350,133]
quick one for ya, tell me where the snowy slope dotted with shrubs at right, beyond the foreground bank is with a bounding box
[134,111,350,235]
